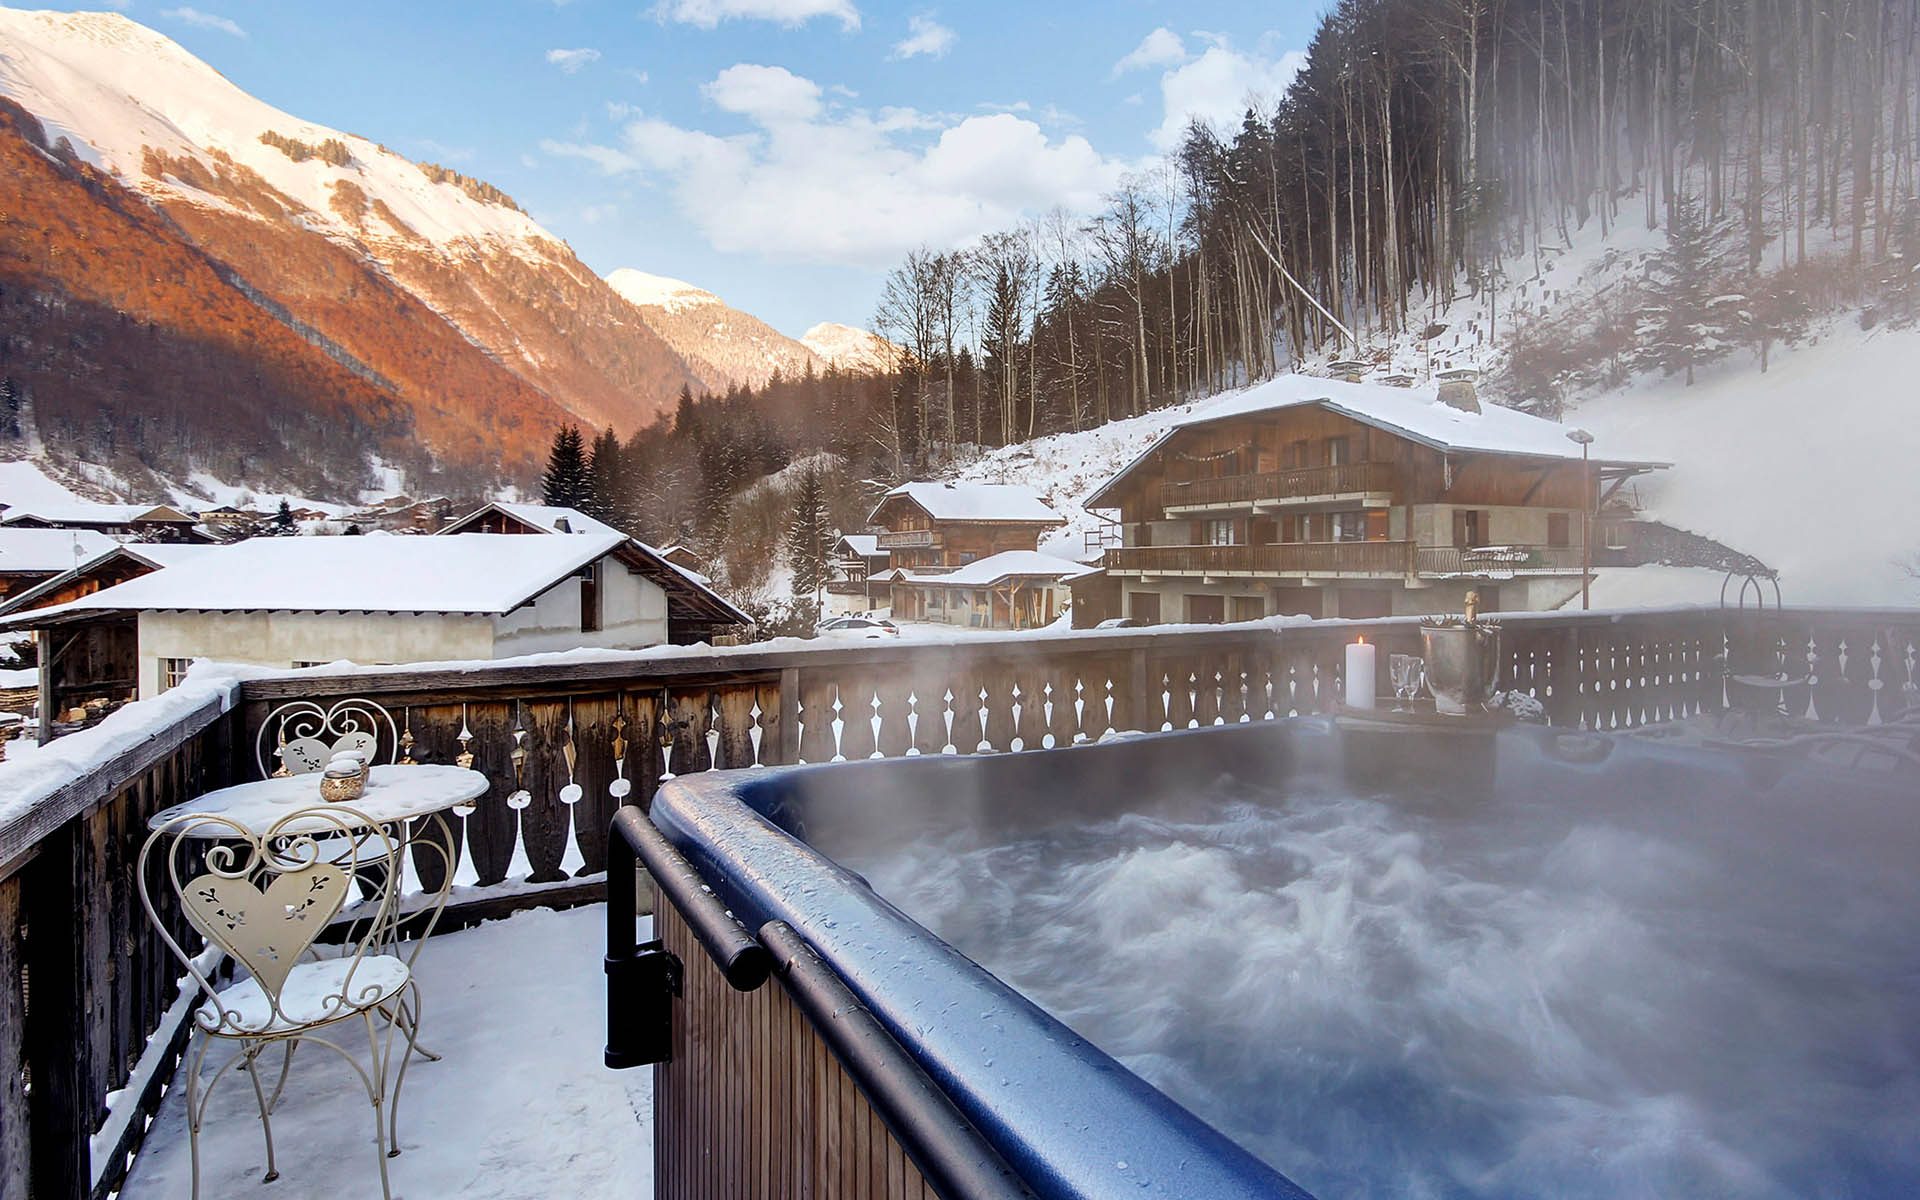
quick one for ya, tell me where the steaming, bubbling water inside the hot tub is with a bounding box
[833,774,1920,1198]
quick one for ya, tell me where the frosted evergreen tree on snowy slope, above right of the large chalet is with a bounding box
[1636,196,1749,388]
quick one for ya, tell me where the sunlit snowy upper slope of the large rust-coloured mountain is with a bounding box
[0,10,559,248]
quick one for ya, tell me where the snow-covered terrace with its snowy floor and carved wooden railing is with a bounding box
[0,607,1920,1200]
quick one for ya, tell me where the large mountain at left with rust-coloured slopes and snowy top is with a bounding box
[0,10,840,495]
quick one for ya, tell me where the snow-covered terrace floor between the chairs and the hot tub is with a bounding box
[121,904,653,1200]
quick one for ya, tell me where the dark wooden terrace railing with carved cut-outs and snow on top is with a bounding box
[11,606,1920,1200]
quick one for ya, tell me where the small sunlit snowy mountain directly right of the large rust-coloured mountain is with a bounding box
[607,267,826,392]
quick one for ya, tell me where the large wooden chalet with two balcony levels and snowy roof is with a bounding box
[1087,372,1667,622]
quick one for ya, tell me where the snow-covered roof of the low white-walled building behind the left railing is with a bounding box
[0,534,624,628]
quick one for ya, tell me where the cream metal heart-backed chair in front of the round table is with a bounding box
[138,804,420,1200]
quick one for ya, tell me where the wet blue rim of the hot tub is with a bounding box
[651,718,1331,1200]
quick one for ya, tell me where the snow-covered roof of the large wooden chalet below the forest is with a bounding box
[1087,374,1672,507]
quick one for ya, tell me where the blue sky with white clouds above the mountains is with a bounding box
[61,0,1321,334]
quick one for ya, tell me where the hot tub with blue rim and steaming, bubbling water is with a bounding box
[622,718,1920,1198]
